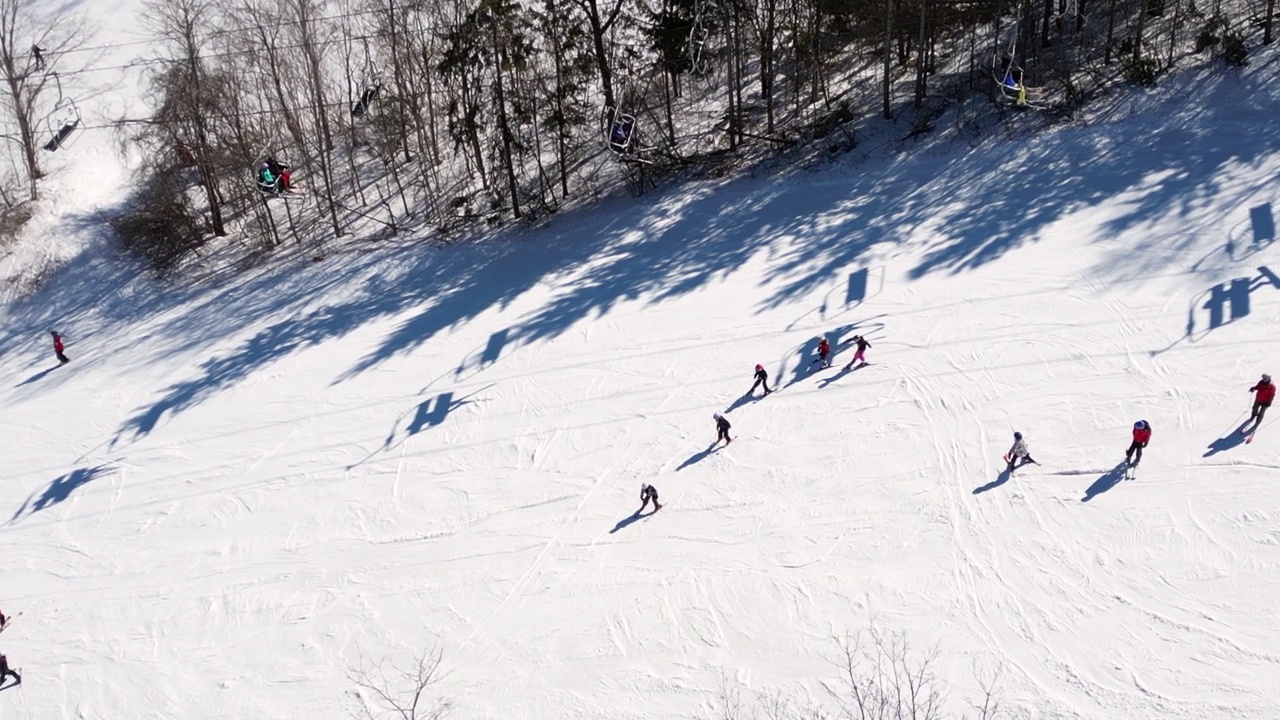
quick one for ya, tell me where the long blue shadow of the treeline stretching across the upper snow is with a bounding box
[17,55,1280,439]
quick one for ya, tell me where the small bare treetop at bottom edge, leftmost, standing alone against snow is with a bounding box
[347,648,453,720]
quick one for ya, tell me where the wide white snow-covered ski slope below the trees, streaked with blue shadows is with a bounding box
[0,43,1280,720]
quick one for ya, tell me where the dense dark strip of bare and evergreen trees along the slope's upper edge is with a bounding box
[102,0,1274,266]
